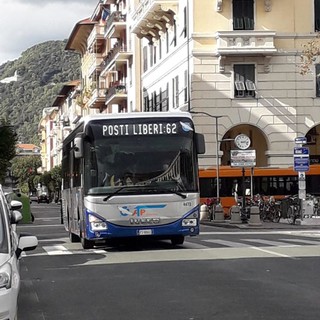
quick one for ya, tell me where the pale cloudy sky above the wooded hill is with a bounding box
[0,0,99,65]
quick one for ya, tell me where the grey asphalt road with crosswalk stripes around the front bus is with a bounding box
[18,203,320,320]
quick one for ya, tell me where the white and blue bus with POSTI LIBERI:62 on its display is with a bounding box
[61,112,205,249]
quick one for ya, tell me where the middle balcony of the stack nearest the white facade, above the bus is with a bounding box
[100,42,132,76]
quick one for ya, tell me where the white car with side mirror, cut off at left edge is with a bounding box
[0,185,38,320]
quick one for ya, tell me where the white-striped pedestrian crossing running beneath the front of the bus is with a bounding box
[22,237,320,257]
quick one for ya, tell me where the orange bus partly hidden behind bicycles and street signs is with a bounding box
[199,164,320,215]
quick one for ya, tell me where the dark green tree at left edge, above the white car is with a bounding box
[0,119,17,181]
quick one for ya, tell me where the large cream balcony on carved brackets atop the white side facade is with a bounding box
[132,0,179,41]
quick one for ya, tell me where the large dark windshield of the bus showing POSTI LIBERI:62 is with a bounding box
[84,120,198,195]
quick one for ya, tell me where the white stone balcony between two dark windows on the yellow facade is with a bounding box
[216,30,277,56]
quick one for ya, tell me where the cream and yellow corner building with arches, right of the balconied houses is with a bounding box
[133,0,320,167]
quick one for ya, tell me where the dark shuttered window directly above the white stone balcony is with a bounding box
[233,0,254,30]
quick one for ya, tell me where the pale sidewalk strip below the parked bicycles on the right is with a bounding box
[200,217,320,230]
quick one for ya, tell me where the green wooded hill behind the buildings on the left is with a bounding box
[0,40,80,145]
